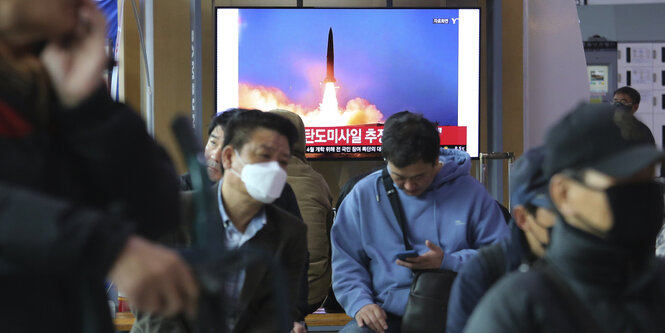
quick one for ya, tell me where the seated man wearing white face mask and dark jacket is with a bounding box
[217,110,307,332]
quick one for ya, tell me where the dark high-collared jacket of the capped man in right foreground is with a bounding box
[465,221,665,333]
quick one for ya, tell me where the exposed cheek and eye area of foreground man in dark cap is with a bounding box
[550,166,654,238]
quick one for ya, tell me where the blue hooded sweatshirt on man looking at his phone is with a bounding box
[331,149,508,317]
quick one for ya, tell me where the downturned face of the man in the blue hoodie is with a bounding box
[388,160,442,196]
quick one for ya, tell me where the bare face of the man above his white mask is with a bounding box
[222,127,291,194]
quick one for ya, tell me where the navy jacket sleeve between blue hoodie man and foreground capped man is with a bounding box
[446,221,534,333]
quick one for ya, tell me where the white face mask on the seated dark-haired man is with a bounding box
[231,150,286,204]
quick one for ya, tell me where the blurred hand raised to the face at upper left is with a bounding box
[41,0,107,108]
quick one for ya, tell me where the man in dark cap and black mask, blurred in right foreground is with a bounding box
[465,104,665,332]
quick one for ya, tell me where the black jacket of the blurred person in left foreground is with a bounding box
[0,86,179,332]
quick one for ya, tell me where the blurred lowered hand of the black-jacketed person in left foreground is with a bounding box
[109,236,199,317]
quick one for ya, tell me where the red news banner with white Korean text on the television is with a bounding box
[305,125,466,146]
